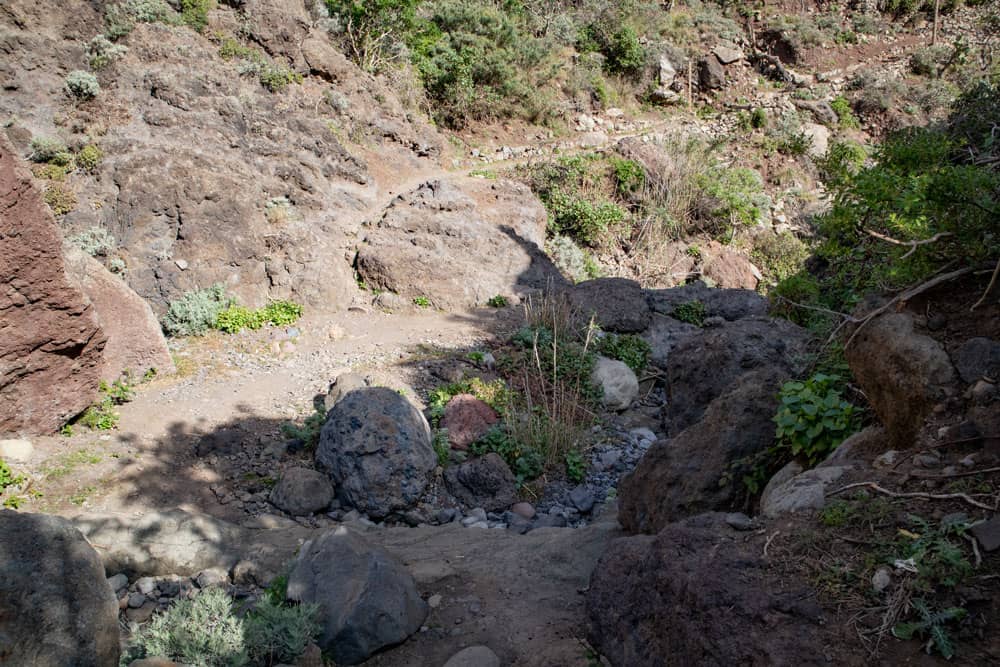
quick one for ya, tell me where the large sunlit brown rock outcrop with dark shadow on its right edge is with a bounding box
[357,178,559,309]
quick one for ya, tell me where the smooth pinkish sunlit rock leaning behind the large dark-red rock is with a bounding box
[66,249,174,382]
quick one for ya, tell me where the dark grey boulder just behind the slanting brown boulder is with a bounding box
[664,317,809,436]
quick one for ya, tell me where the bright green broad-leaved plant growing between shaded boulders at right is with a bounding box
[774,373,860,466]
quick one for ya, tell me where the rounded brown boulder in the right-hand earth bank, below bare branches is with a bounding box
[844,313,955,449]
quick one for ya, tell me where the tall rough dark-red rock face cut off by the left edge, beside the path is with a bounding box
[0,137,107,433]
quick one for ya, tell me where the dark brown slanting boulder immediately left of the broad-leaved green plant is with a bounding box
[618,367,787,533]
